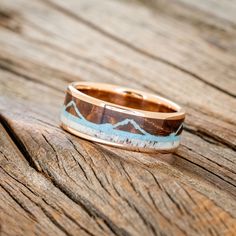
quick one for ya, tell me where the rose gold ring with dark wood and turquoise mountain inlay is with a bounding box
[61,82,185,153]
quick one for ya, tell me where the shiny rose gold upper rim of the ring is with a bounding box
[66,82,185,120]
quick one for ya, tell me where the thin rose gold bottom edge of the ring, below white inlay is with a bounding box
[60,123,177,154]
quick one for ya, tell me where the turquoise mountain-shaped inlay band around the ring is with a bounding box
[62,101,182,142]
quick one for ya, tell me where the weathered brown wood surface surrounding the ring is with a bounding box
[0,0,236,236]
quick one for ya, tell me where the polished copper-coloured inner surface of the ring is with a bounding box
[77,88,177,113]
